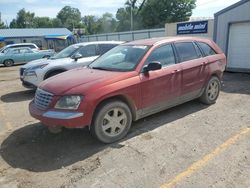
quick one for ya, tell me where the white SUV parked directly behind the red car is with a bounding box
[20,41,124,88]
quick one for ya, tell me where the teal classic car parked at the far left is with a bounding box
[0,47,55,67]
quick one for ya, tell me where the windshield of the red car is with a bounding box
[89,45,149,71]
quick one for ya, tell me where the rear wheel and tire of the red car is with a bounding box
[200,76,221,105]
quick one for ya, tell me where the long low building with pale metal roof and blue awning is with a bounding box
[0,28,75,51]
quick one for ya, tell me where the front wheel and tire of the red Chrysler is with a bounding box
[90,100,132,143]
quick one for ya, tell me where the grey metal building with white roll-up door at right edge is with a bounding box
[214,0,250,72]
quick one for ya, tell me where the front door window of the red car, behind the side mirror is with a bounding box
[145,44,175,66]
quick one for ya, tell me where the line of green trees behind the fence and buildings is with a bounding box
[0,0,196,34]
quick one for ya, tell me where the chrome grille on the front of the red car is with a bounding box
[35,88,53,109]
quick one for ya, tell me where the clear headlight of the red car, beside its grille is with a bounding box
[55,95,83,110]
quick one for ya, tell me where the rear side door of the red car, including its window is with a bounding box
[174,42,208,100]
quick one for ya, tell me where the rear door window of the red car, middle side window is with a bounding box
[175,42,199,62]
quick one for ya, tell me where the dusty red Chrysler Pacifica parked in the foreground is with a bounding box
[29,37,226,143]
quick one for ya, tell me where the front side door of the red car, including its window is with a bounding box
[140,44,181,115]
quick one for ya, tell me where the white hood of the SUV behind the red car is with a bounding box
[22,57,72,69]
